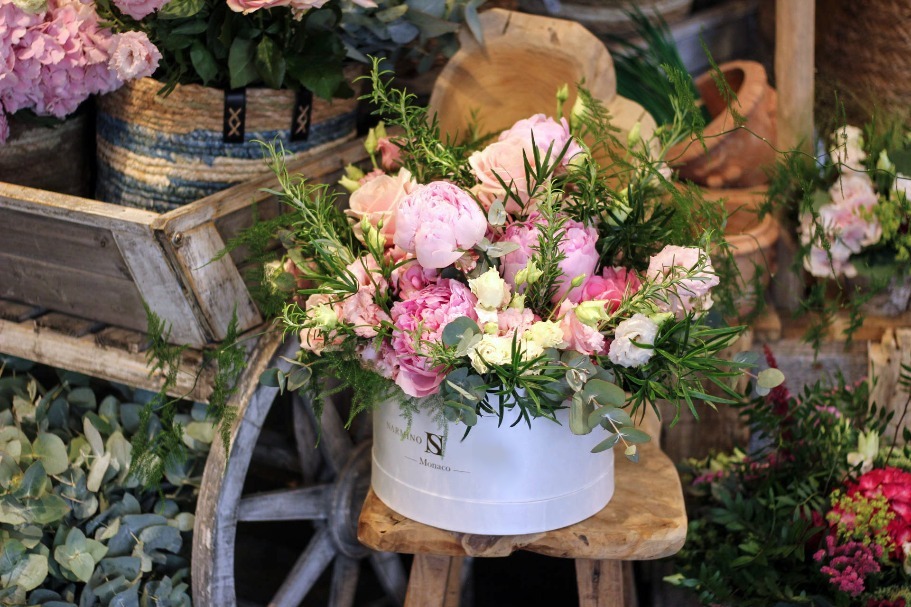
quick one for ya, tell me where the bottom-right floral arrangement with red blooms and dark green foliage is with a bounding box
[667,354,911,607]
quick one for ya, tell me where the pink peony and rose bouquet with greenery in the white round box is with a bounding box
[258,65,756,459]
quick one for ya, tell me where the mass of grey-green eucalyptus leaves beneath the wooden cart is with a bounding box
[0,359,215,607]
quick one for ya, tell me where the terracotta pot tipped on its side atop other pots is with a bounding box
[668,61,777,188]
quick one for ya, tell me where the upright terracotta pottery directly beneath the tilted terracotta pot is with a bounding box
[703,186,780,317]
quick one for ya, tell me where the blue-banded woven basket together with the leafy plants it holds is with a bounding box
[92,0,480,209]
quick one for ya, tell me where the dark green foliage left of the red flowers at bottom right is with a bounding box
[666,381,911,607]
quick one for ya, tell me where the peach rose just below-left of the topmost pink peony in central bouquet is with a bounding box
[468,139,534,215]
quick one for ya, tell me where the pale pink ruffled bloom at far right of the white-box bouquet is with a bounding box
[646,245,720,318]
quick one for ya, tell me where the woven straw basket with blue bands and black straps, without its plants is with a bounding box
[95,66,361,212]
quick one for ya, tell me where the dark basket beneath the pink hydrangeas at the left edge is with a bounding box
[0,113,92,196]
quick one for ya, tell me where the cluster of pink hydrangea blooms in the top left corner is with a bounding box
[0,0,160,144]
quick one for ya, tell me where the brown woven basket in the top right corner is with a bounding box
[816,0,911,124]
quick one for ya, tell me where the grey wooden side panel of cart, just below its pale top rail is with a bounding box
[0,208,130,278]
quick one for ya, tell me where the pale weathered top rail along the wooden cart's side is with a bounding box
[0,182,158,231]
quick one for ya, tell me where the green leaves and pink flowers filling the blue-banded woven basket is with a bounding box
[97,0,481,99]
